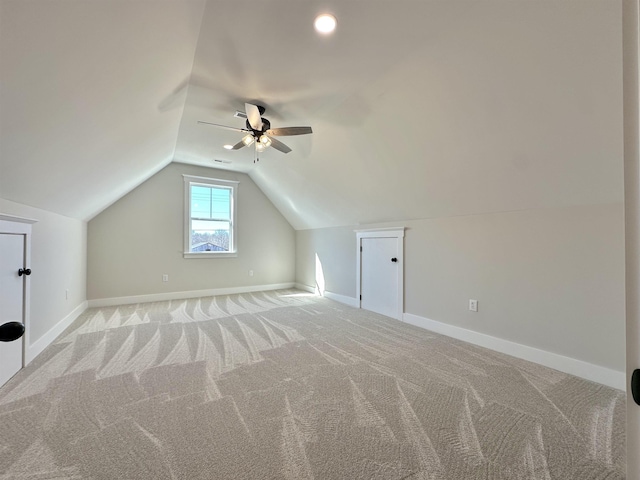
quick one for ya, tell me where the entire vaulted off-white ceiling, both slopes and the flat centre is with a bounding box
[0,0,622,229]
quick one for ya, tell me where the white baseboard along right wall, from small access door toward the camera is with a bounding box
[403,313,627,391]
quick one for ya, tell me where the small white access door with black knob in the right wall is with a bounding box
[360,237,402,318]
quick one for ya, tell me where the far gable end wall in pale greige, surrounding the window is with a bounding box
[87,163,295,299]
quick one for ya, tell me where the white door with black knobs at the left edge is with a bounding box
[0,234,25,387]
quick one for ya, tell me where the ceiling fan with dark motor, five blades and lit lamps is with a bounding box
[198,103,313,163]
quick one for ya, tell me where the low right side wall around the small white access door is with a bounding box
[296,203,625,372]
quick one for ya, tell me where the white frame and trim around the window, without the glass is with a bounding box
[182,175,240,258]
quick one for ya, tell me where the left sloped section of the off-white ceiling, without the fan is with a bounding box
[0,0,204,220]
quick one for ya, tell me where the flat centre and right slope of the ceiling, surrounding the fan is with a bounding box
[176,0,622,229]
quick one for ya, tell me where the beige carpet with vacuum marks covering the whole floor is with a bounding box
[0,290,625,480]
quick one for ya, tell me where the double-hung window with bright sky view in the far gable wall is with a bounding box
[183,175,238,258]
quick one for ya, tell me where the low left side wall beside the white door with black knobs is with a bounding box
[0,198,87,348]
